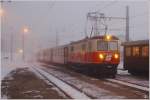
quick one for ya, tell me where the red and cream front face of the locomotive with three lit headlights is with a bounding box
[96,35,120,65]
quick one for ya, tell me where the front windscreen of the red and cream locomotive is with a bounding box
[97,41,118,50]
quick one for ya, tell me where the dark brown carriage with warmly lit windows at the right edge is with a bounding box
[123,40,149,76]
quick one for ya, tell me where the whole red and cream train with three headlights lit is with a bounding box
[37,35,120,78]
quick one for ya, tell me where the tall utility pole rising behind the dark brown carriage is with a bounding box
[126,6,129,41]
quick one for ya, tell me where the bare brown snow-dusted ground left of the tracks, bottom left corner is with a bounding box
[1,67,69,99]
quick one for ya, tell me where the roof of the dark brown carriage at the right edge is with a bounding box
[122,40,149,46]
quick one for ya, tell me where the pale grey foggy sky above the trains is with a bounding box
[1,0,148,54]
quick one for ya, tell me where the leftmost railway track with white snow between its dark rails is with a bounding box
[32,67,94,99]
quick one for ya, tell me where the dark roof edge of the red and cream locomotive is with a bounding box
[71,35,119,44]
